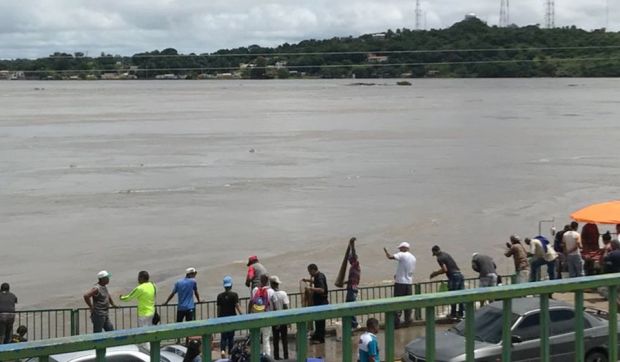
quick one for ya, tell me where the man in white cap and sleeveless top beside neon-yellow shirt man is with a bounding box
[84,270,116,333]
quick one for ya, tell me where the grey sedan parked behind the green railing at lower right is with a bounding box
[401,298,617,362]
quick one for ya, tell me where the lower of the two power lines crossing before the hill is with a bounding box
[12,57,620,74]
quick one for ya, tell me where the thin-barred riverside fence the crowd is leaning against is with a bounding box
[15,276,511,341]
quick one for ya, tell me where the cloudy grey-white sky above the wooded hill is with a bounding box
[0,0,620,59]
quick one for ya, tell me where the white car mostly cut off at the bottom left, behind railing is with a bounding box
[27,344,184,362]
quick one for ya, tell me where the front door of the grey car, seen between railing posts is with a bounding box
[512,311,540,362]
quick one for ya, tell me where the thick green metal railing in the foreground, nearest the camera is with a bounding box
[0,274,620,362]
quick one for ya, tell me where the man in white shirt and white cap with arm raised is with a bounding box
[383,241,416,328]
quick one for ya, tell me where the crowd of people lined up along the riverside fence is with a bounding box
[0,222,620,360]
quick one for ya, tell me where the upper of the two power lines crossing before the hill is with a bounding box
[23,45,620,60]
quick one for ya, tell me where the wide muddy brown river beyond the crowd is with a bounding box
[0,79,620,308]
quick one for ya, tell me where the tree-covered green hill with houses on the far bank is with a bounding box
[0,18,620,79]
